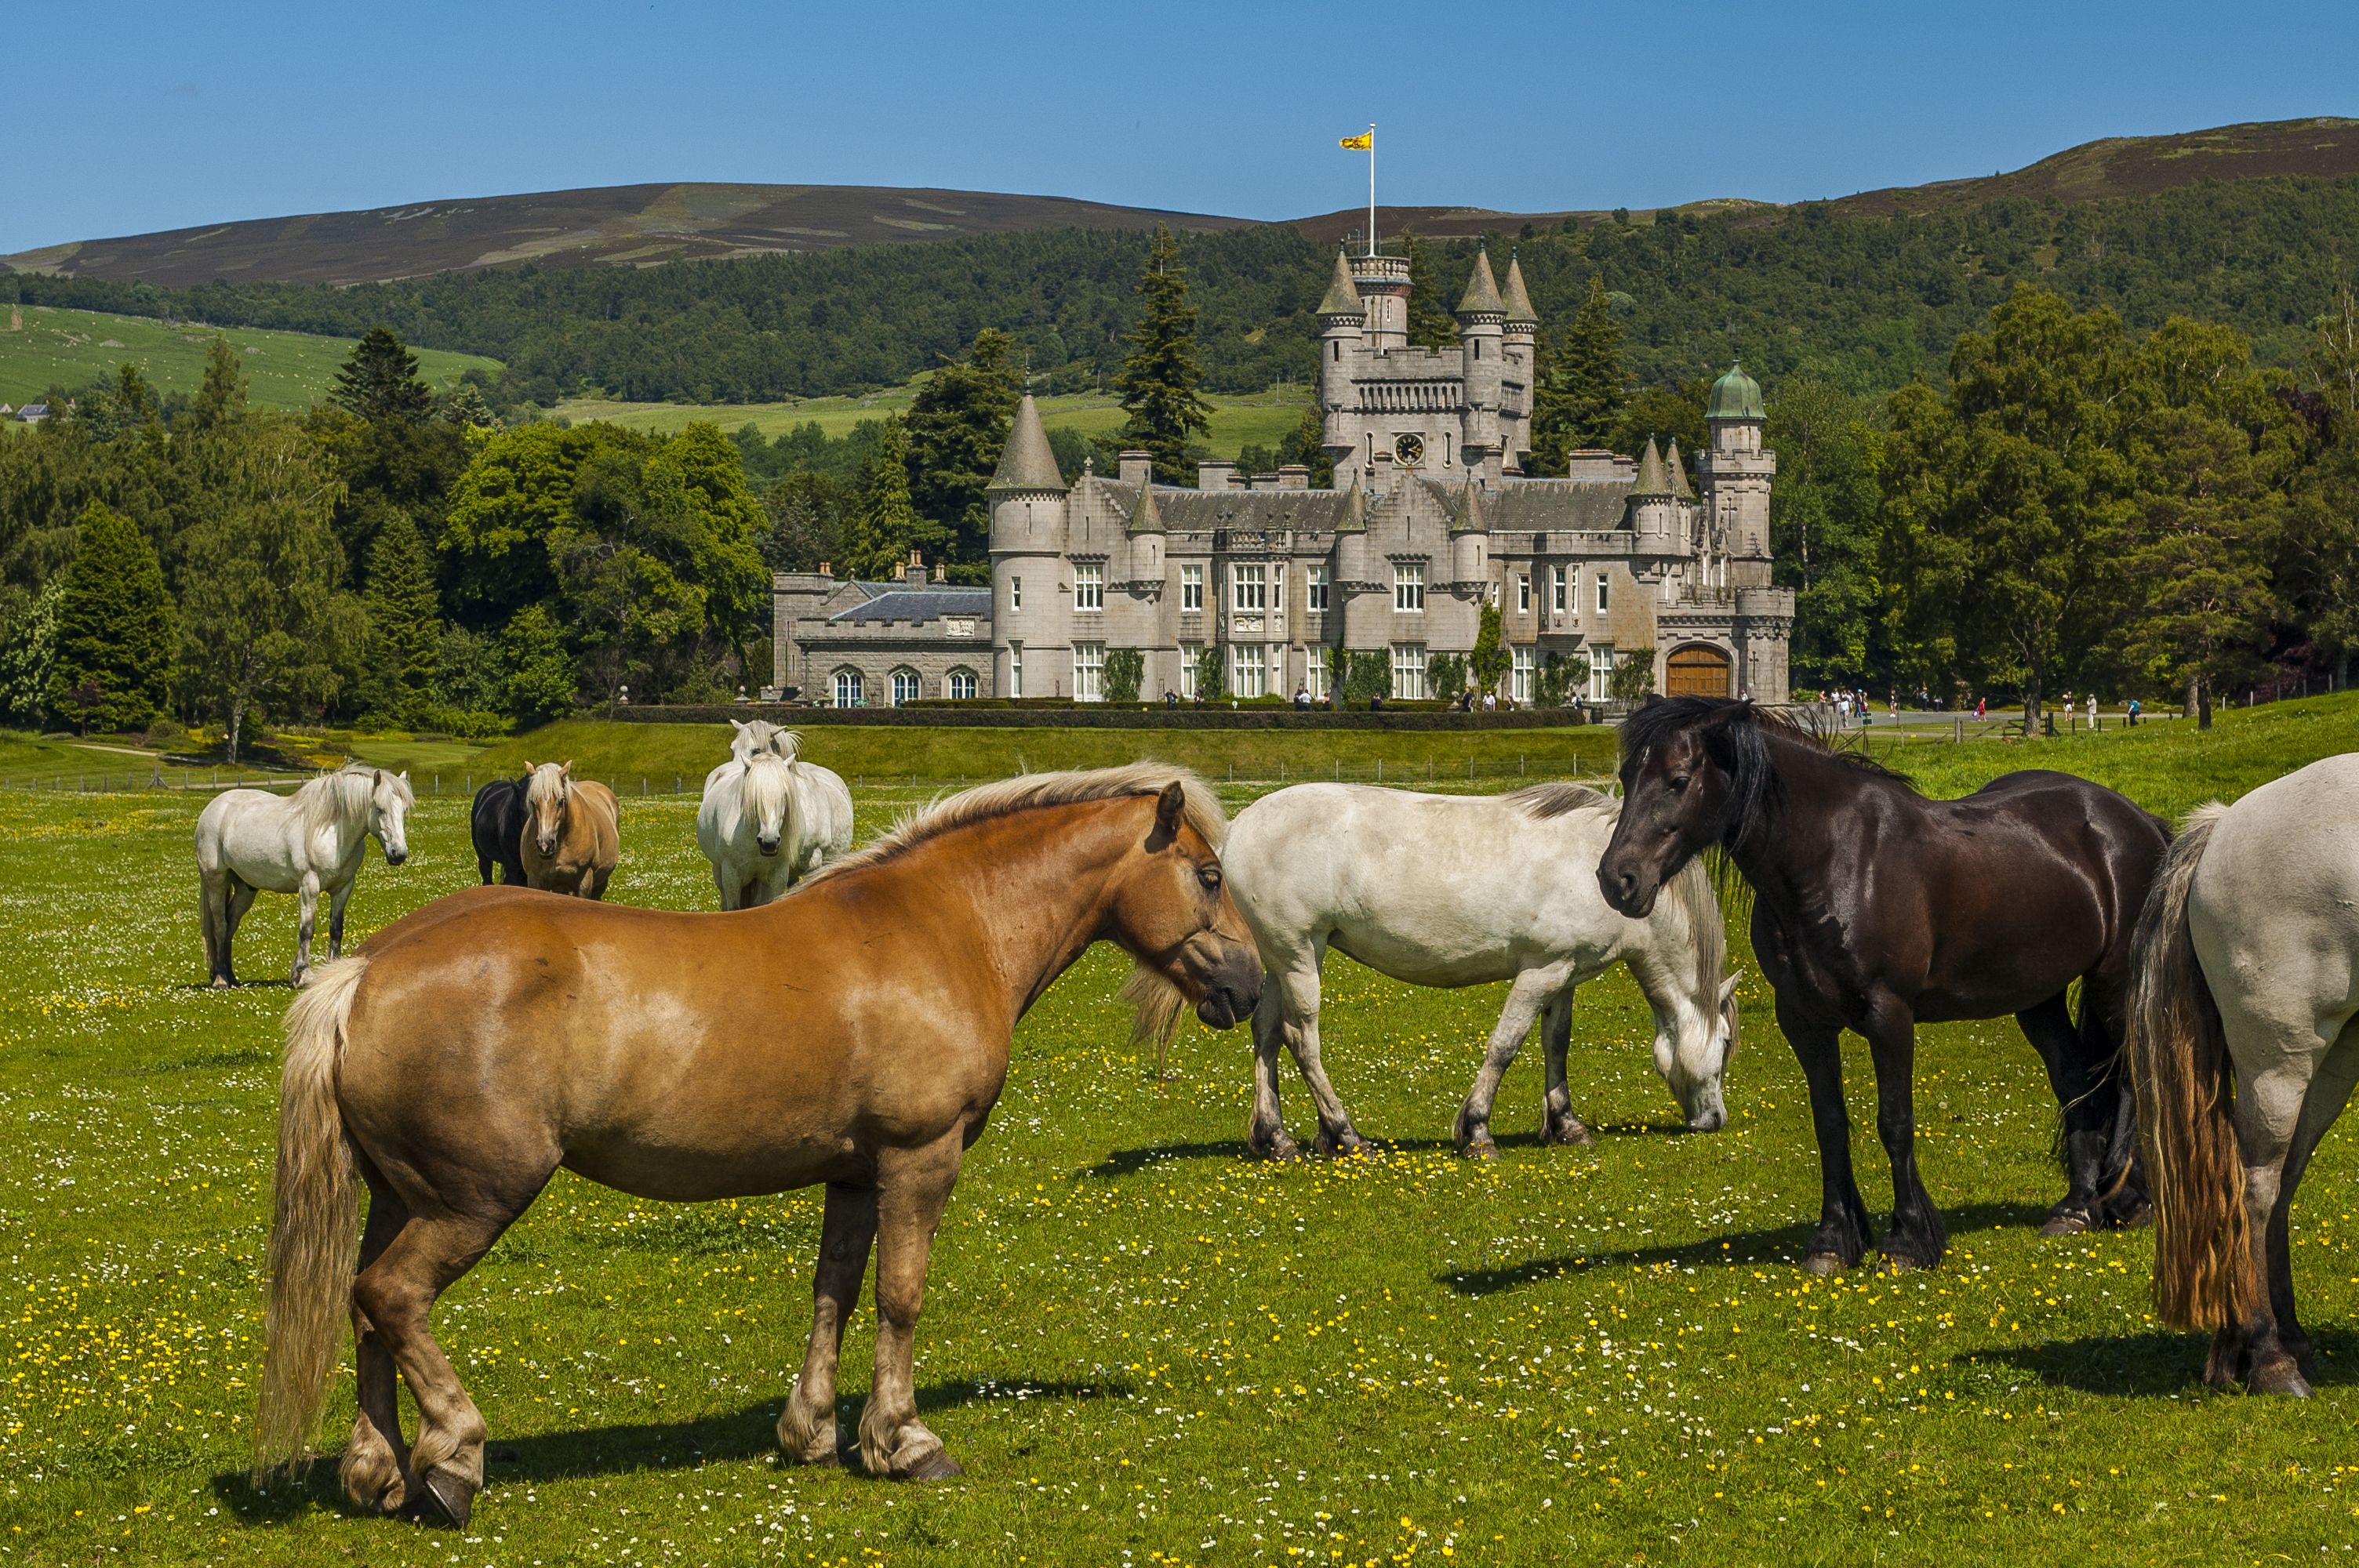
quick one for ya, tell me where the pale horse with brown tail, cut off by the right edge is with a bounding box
[2128,754,2359,1396]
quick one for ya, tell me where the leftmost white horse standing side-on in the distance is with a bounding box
[196,764,417,985]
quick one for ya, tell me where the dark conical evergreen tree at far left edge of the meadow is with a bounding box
[47,503,175,733]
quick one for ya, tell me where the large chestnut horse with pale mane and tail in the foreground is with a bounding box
[255,764,1262,1526]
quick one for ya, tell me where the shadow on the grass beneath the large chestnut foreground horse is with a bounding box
[213,1379,1132,1526]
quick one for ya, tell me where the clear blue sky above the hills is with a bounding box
[0,0,2359,252]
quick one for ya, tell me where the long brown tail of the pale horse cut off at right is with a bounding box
[2125,802,2258,1327]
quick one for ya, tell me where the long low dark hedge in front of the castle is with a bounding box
[613,702,1587,731]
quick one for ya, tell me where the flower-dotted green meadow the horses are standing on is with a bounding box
[0,698,2359,1568]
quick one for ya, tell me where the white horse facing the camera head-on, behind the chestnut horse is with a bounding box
[696,719,852,910]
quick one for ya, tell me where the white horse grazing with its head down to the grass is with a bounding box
[1219,782,1736,1158]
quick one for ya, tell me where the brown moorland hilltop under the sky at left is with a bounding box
[0,184,1245,288]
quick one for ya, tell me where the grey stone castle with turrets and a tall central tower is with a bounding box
[774,242,1793,707]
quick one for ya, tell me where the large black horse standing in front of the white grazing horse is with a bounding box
[1597,698,2170,1273]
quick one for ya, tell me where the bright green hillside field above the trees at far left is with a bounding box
[0,304,500,408]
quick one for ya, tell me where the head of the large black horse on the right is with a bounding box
[1597,695,1776,920]
